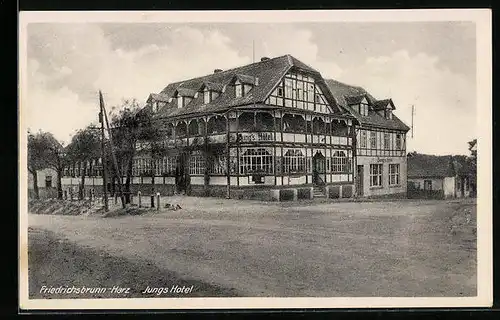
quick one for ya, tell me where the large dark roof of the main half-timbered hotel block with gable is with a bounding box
[148,55,346,117]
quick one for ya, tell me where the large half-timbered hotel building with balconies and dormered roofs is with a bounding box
[57,55,408,200]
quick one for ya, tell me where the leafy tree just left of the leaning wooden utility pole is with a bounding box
[66,125,101,200]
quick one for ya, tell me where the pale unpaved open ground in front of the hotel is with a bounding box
[29,197,476,297]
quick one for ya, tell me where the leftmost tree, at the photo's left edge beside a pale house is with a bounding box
[28,131,66,199]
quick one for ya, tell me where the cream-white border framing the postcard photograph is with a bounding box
[19,9,493,309]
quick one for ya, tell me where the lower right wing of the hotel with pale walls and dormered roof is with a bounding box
[326,79,410,197]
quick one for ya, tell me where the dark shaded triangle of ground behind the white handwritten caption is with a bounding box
[28,228,238,299]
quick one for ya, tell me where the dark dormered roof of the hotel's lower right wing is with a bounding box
[325,79,410,131]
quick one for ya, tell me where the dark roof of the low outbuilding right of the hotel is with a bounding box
[408,153,455,178]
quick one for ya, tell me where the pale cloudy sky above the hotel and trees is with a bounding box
[26,22,477,155]
